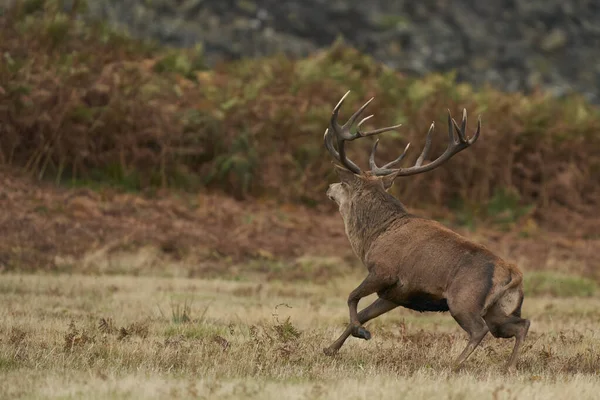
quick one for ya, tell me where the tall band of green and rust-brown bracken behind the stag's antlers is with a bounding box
[0,1,600,227]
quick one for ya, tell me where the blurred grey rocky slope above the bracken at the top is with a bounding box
[10,0,600,102]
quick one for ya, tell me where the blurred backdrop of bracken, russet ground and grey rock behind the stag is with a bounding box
[0,0,600,290]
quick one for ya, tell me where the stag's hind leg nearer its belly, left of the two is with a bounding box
[448,300,489,371]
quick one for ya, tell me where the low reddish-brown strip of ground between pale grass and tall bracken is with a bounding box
[0,170,600,282]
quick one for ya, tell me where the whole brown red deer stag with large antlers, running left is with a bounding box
[323,91,530,370]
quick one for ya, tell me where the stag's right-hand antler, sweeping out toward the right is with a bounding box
[369,109,481,176]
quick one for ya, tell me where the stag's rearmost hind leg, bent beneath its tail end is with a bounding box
[484,308,531,371]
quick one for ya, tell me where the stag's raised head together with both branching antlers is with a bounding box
[323,91,481,211]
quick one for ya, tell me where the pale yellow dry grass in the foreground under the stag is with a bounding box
[0,274,600,400]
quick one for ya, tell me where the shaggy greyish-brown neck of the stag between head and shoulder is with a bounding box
[340,191,408,261]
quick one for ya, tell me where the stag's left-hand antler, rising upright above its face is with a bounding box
[323,90,400,174]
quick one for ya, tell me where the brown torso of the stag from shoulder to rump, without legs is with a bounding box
[365,216,523,317]
